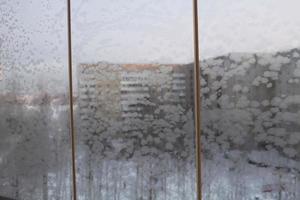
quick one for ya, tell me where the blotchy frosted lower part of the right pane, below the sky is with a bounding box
[201,49,300,200]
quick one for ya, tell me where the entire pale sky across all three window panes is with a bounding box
[0,0,300,93]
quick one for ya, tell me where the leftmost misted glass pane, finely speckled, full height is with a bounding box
[0,0,71,200]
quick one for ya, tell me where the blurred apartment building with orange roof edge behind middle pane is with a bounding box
[78,63,193,126]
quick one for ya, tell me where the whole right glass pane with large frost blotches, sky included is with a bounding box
[199,0,300,200]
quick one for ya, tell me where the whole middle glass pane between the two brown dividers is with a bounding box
[72,0,196,200]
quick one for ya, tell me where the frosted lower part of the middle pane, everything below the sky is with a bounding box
[78,62,196,200]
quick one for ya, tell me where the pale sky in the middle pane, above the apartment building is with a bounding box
[73,0,193,63]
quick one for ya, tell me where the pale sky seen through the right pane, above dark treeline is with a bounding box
[199,0,300,58]
